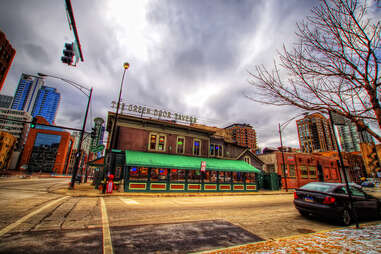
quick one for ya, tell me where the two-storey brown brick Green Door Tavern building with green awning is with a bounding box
[106,112,263,192]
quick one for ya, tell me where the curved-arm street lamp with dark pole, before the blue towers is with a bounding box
[37,73,93,189]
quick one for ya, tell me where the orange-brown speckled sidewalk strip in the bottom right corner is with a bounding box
[199,221,381,254]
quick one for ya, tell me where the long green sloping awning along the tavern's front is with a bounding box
[126,150,260,173]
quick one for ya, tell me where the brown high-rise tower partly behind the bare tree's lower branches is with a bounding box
[296,113,336,153]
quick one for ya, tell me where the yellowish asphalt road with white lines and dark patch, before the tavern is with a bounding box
[0,179,378,253]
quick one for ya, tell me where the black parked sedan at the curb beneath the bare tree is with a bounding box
[294,182,381,225]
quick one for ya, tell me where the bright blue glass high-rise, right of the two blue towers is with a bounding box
[32,86,61,124]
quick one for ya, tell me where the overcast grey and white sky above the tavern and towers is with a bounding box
[0,0,318,148]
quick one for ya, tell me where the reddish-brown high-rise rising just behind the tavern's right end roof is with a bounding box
[225,123,257,151]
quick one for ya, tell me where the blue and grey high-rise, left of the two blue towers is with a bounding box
[11,73,45,114]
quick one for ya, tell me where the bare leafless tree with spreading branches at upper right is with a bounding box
[249,0,381,142]
